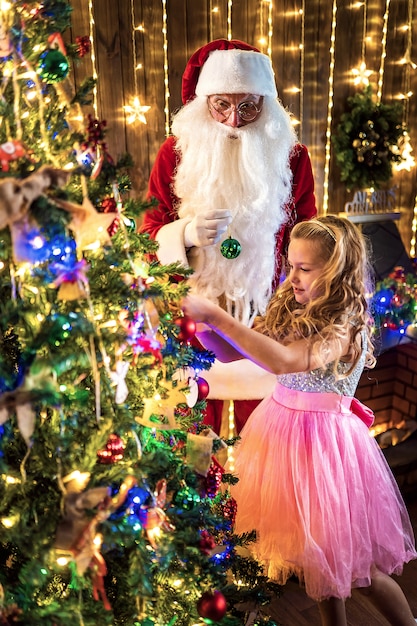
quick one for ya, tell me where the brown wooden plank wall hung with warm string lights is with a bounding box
[68,0,417,249]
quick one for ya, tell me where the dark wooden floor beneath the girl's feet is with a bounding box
[264,496,417,626]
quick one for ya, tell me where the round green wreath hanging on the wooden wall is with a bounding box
[332,87,405,191]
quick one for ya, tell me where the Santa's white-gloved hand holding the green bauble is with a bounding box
[184,209,232,248]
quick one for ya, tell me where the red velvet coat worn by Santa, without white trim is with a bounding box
[140,137,317,432]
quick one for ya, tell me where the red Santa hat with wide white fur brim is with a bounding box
[182,39,278,104]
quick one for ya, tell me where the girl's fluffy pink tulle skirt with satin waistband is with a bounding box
[232,384,417,600]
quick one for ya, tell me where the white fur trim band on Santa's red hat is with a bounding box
[195,49,278,98]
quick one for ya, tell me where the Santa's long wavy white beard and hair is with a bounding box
[172,97,297,325]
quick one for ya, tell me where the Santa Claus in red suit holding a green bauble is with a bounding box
[141,39,316,432]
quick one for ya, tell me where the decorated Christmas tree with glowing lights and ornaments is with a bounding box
[0,0,279,626]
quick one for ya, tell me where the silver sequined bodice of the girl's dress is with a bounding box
[277,341,366,396]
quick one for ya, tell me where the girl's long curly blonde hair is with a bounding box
[254,215,375,375]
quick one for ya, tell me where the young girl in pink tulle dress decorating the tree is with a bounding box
[184,215,417,626]
